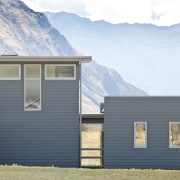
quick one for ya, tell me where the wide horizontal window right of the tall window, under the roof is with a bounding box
[45,64,76,80]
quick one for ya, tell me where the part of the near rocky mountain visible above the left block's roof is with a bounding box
[0,0,76,56]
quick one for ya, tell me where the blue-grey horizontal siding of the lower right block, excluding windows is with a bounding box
[104,97,180,169]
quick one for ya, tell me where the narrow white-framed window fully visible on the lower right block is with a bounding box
[134,122,147,148]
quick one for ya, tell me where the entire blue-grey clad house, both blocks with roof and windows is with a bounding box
[0,56,180,169]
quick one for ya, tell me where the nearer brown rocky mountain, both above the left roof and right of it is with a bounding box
[0,0,147,113]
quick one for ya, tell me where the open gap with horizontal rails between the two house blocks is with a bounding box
[81,116,103,168]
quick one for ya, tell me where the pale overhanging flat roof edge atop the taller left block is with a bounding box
[0,55,92,63]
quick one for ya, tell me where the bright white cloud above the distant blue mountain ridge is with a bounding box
[85,0,180,26]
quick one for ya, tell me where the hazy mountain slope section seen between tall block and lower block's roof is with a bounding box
[82,61,147,113]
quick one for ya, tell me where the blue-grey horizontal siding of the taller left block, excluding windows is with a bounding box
[0,63,80,167]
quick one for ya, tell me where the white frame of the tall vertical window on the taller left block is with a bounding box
[24,64,42,111]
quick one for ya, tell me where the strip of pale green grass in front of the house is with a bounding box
[0,166,180,180]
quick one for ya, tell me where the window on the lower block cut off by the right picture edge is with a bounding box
[169,122,180,148]
